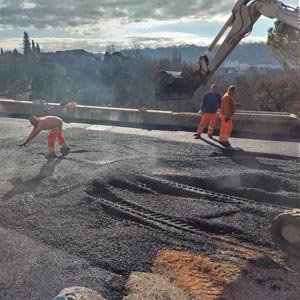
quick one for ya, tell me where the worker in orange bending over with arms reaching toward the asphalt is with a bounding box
[20,116,70,156]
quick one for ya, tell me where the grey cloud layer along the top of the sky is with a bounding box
[0,0,235,28]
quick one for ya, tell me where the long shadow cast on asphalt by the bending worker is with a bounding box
[2,154,63,200]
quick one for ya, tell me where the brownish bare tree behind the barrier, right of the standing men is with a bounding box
[254,72,300,111]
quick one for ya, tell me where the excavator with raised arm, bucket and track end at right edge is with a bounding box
[155,0,300,258]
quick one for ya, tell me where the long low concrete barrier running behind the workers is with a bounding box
[0,99,300,136]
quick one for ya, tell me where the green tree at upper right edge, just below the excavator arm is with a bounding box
[267,21,300,70]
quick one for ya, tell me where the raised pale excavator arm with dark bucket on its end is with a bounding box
[155,0,299,100]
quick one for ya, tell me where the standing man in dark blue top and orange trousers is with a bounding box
[194,84,221,138]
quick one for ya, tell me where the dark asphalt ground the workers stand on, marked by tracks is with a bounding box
[0,118,300,300]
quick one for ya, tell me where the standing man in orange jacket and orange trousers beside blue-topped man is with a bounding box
[219,85,237,147]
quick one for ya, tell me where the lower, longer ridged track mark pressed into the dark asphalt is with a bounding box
[87,176,278,255]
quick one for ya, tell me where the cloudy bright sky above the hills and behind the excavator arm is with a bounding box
[0,0,299,53]
